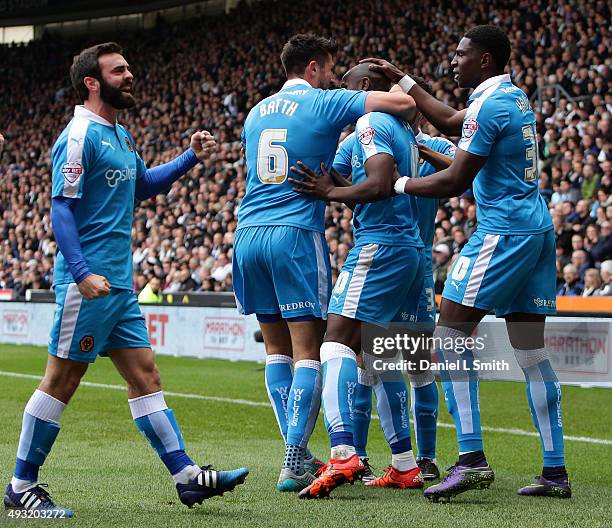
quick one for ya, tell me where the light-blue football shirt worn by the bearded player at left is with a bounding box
[51,106,146,290]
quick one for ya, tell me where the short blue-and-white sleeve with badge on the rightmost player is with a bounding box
[457,97,510,156]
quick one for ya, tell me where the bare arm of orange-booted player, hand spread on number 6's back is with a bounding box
[289,153,395,204]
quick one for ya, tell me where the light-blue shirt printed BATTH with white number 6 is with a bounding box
[238,79,367,233]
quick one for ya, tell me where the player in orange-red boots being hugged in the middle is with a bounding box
[289,65,425,499]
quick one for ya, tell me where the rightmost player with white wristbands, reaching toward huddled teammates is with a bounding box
[366,26,571,501]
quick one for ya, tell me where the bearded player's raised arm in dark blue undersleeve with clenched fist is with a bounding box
[136,130,217,200]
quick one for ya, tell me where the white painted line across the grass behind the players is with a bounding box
[0,370,612,445]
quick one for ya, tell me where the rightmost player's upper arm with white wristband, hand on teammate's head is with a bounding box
[360,57,465,136]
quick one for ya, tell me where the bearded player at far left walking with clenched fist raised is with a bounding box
[4,42,248,517]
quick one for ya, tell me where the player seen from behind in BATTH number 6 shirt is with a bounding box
[233,35,414,491]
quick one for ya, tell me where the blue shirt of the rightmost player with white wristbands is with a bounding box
[457,74,552,235]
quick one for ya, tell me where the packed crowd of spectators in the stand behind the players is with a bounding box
[0,0,612,296]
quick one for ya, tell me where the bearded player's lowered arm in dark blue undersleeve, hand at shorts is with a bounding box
[51,197,110,300]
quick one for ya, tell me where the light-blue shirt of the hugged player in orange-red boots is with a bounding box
[334,112,423,247]
